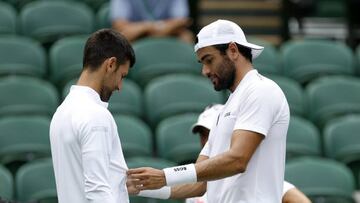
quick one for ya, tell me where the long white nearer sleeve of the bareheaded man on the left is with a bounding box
[80,116,115,203]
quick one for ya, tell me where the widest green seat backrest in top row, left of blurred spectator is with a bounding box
[19,1,94,43]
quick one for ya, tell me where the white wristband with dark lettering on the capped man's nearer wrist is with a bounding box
[163,164,197,186]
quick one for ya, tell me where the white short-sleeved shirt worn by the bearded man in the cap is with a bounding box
[201,70,290,203]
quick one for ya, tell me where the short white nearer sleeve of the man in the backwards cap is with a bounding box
[234,85,281,136]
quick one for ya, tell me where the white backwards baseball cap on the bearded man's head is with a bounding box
[194,20,264,59]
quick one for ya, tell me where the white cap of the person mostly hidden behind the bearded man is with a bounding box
[192,104,224,133]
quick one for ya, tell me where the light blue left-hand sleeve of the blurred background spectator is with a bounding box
[110,0,131,21]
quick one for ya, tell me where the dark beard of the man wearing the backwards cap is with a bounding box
[214,56,236,91]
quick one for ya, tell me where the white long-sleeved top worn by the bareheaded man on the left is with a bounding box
[50,85,129,203]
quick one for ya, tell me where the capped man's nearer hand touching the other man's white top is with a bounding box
[127,167,166,190]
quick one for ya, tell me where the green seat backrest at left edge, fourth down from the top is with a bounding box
[0,116,50,164]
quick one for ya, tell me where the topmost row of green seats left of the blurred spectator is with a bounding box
[0,0,111,44]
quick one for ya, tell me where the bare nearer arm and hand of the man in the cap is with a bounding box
[128,130,264,190]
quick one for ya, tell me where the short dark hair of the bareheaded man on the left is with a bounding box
[83,29,135,70]
